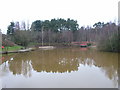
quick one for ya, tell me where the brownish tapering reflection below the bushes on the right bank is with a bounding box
[94,52,118,86]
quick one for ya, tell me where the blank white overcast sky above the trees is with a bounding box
[0,0,119,33]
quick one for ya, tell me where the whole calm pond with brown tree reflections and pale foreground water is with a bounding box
[0,48,118,88]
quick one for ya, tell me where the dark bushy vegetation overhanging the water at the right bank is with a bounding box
[97,24,120,52]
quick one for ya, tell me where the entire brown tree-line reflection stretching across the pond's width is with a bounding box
[1,48,118,83]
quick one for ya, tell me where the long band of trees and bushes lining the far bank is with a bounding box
[4,18,120,51]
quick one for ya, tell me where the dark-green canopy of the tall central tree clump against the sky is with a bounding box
[31,18,79,32]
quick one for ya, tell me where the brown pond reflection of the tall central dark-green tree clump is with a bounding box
[32,51,79,73]
